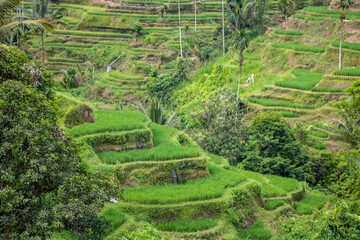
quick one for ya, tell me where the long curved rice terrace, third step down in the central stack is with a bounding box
[123,163,246,204]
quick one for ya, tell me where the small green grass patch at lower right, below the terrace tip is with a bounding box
[294,194,326,215]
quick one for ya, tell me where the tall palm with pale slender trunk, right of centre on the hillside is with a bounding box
[228,1,257,101]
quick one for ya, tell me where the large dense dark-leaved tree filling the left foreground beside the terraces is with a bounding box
[0,47,107,239]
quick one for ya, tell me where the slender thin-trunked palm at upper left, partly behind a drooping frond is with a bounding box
[30,0,65,63]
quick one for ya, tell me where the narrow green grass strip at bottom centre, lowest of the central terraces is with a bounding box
[154,218,217,232]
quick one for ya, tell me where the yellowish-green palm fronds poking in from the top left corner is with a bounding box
[0,0,53,36]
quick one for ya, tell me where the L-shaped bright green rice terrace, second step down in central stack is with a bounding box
[99,124,202,164]
